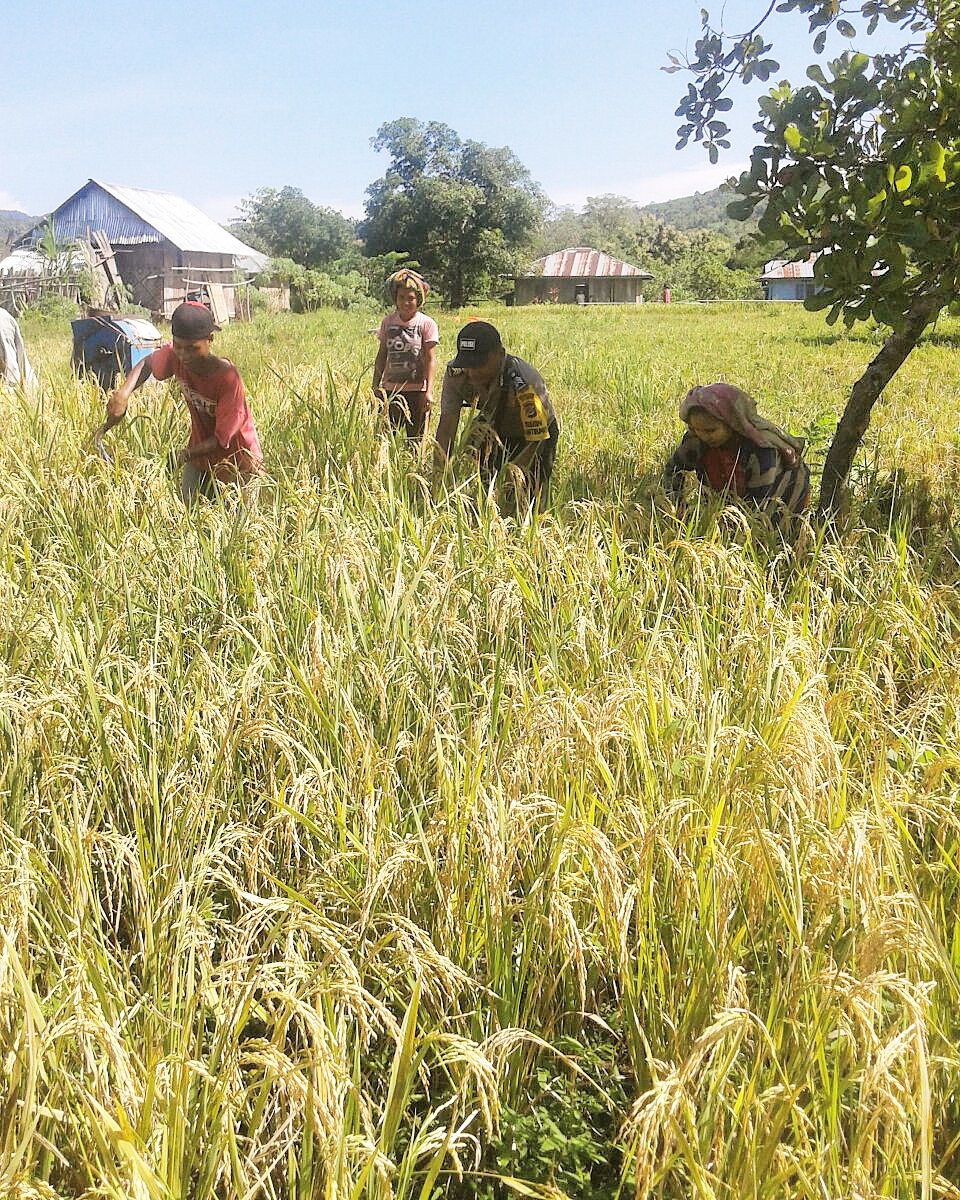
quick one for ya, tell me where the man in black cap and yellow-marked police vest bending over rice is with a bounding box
[437,320,559,509]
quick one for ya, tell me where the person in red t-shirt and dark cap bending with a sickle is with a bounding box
[95,301,263,505]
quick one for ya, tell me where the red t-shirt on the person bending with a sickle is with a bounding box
[150,346,263,470]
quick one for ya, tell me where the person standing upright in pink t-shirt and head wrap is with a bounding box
[373,268,439,442]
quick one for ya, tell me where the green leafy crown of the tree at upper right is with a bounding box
[680,0,960,329]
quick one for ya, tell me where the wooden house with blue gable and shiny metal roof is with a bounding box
[18,179,269,320]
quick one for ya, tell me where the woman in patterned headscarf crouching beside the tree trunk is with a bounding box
[664,383,810,522]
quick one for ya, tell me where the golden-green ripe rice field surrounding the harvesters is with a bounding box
[0,305,960,1200]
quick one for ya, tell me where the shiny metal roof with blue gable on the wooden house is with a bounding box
[21,179,269,266]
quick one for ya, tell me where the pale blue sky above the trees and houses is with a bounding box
[0,0,902,221]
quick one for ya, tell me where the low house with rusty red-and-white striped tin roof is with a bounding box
[514,246,653,304]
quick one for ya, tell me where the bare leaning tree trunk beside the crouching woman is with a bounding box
[818,295,943,516]
